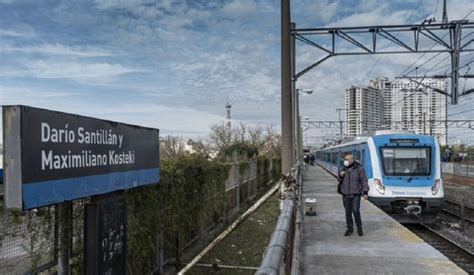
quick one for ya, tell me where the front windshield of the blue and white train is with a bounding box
[382,147,431,176]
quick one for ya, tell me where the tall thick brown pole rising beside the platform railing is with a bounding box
[281,0,294,174]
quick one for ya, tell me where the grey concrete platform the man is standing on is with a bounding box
[301,166,466,274]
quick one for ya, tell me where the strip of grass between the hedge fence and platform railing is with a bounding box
[189,195,280,274]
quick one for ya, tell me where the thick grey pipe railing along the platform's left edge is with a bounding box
[256,165,301,275]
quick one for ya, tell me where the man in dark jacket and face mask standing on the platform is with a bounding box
[338,153,369,236]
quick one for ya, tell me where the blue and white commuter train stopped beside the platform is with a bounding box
[314,131,444,223]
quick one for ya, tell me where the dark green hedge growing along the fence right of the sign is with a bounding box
[126,155,278,274]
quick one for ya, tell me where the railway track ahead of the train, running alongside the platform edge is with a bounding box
[404,224,474,274]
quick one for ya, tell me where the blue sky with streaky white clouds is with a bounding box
[0,0,474,146]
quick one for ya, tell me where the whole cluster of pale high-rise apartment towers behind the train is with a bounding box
[345,77,447,144]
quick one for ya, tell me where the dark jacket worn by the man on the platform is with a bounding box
[338,162,369,196]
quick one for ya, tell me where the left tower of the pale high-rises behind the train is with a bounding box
[345,86,384,136]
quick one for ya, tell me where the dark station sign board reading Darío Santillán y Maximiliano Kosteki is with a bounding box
[3,106,159,209]
